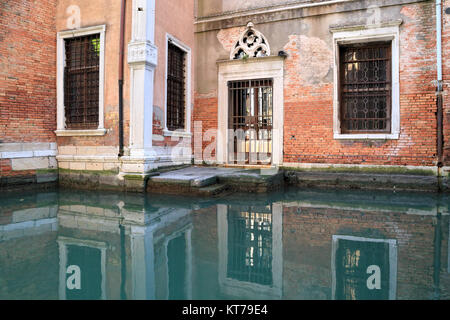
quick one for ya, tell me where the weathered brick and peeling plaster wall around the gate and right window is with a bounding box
[194,1,440,166]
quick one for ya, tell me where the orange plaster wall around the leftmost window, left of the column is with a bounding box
[56,0,131,156]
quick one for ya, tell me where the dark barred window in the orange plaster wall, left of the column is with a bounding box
[64,34,100,129]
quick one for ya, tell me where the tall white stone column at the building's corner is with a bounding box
[127,0,158,164]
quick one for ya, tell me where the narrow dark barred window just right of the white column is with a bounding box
[167,43,186,131]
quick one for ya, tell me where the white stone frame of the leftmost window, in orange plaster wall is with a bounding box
[55,25,106,137]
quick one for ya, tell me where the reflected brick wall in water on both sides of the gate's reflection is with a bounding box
[188,203,449,300]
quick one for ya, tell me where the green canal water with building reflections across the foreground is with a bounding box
[0,189,450,300]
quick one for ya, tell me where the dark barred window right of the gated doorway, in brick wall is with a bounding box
[339,42,392,133]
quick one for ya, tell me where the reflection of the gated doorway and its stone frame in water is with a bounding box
[217,203,283,299]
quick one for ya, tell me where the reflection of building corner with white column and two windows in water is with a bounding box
[58,191,192,300]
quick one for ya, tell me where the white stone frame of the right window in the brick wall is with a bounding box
[331,21,401,140]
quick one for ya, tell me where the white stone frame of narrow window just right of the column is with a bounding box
[163,33,192,138]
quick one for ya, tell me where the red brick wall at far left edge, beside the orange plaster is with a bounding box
[0,0,57,177]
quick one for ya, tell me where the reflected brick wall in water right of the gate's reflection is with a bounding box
[283,206,448,300]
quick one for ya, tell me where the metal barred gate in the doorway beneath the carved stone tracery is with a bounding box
[228,79,273,165]
